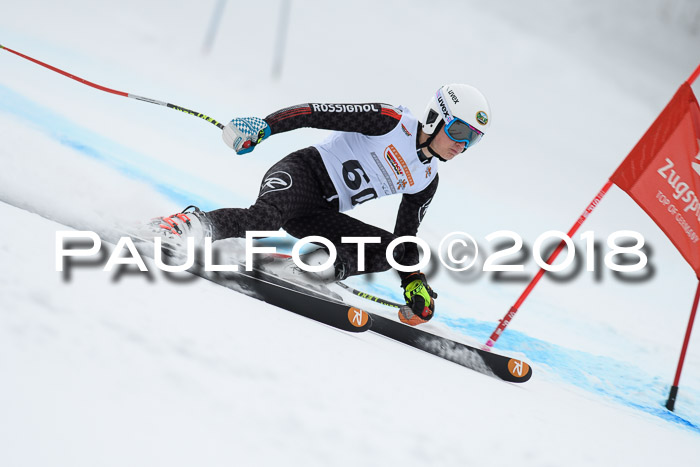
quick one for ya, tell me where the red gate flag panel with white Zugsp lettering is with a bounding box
[611,83,700,278]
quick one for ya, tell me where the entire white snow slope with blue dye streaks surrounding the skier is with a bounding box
[0,0,700,466]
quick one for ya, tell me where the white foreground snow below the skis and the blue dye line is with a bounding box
[0,204,698,466]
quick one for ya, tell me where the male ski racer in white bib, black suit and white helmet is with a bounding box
[154,84,491,325]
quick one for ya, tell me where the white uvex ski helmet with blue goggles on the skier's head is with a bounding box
[422,84,491,152]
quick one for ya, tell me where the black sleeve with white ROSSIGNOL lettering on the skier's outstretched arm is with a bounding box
[265,104,401,136]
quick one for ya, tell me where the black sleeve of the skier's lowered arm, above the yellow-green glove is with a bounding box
[394,175,439,279]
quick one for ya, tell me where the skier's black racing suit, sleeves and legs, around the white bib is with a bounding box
[207,104,438,279]
